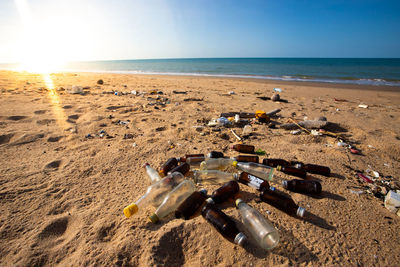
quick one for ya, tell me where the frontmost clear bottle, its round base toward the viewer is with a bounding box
[236,198,279,249]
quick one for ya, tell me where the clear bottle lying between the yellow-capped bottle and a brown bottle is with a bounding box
[149,180,196,223]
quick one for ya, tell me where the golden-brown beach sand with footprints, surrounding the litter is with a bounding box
[0,71,400,266]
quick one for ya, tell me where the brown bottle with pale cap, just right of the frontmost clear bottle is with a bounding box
[260,189,305,217]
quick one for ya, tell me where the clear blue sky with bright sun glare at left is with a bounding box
[0,0,400,63]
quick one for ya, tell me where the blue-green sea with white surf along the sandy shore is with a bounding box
[0,58,400,86]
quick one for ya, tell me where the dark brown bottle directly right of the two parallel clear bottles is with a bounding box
[175,189,207,220]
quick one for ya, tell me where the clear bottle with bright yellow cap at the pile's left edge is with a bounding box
[124,172,185,218]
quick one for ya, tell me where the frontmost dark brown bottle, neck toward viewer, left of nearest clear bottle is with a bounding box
[201,204,246,245]
